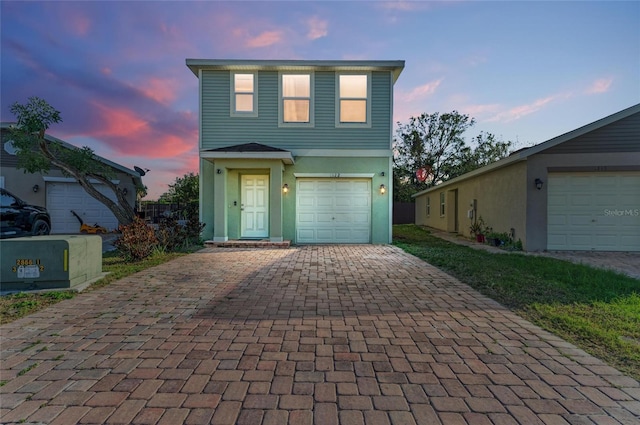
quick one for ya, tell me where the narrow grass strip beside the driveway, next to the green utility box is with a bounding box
[0,246,201,324]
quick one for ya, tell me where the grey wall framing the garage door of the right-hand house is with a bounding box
[526,151,640,251]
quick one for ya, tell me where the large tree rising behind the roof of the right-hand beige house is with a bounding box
[393,111,511,202]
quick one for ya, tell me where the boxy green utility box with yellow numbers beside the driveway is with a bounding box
[0,235,103,291]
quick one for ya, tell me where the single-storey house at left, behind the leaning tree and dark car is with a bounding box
[0,123,142,234]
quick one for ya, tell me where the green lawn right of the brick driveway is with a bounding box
[393,225,640,379]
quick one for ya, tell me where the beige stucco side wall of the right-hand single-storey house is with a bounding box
[416,161,528,243]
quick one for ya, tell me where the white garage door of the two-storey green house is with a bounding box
[296,179,371,243]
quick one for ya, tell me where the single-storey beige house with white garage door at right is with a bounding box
[413,104,640,251]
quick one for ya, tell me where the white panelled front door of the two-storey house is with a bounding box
[240,175,269,238]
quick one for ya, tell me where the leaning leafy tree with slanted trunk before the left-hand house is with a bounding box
[10,97,135,225]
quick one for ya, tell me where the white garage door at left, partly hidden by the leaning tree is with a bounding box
[47,182,118,233]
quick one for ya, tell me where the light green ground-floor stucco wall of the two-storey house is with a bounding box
[200,157,392,243]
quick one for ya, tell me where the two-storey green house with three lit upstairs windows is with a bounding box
[186,59,404,244]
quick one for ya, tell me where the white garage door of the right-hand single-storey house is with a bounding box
[547,172,640,251]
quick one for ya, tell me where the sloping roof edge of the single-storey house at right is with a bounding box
[411,103,640,198]
